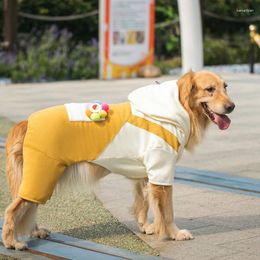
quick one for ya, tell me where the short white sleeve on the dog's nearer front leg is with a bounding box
[144,148,177,185]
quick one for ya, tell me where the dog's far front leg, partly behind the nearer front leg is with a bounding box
[132,179,149,233]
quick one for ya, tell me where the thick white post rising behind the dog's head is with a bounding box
[178,0,203,73]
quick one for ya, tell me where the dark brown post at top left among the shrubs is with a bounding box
[4,0,17,51]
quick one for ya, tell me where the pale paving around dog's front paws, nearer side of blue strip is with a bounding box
[98,175,260,260]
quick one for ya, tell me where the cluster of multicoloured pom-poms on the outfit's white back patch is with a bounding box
[86,101,109,121]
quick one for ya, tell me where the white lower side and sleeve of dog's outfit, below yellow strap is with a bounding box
[94,123,183,185]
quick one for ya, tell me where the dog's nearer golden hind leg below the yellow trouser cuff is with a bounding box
[2,198,35,250]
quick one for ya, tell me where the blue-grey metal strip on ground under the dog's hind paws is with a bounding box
[0,220,162,260]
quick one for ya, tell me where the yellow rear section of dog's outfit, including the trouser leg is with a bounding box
[19,103,131,203]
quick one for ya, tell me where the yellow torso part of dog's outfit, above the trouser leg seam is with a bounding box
[24,103,131,165]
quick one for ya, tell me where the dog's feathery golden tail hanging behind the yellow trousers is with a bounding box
[6,121,28,199]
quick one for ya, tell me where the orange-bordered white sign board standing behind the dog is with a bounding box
[99,0,155,79]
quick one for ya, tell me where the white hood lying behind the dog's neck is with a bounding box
[128,80,190,144]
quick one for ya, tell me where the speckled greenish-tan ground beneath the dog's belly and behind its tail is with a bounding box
[0,118,158,259]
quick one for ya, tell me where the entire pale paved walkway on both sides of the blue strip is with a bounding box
[0,74,260,260]
